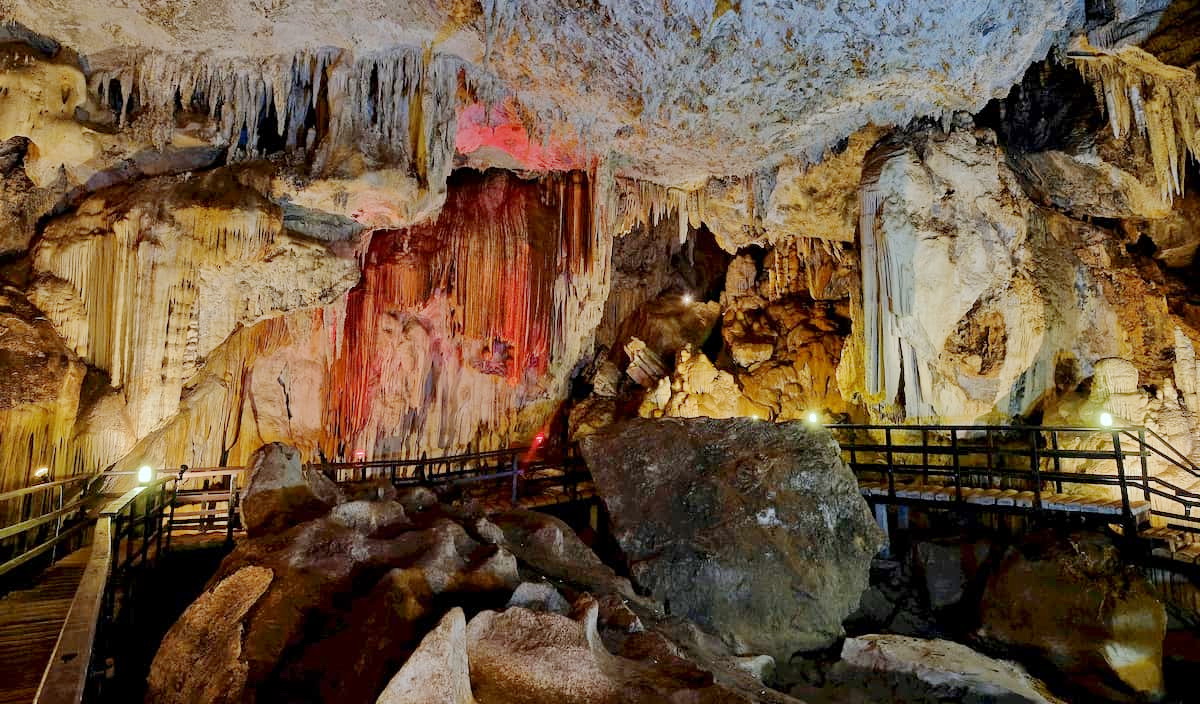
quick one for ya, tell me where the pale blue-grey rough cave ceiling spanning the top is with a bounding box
[7,0,1162,187]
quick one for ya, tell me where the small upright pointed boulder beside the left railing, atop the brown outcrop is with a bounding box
[241,443,341,536]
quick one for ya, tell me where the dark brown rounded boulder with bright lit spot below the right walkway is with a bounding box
[979,532,1166,699]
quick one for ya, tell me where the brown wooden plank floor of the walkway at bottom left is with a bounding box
[0,548,91,704]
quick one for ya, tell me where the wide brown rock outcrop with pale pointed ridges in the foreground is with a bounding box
[146,446,794,704]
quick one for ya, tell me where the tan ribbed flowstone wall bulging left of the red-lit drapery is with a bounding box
[31,170,359,438]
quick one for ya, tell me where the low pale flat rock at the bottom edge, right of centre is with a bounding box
[832,634,1061,704]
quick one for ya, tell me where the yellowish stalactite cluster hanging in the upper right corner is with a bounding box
[1070,38,1200,200]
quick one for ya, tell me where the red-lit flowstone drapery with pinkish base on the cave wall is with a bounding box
[325,173,607,455]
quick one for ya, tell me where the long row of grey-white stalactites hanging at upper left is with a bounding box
[89,46,505,184]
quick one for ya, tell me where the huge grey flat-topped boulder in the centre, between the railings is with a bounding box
[582,419,882,661]
